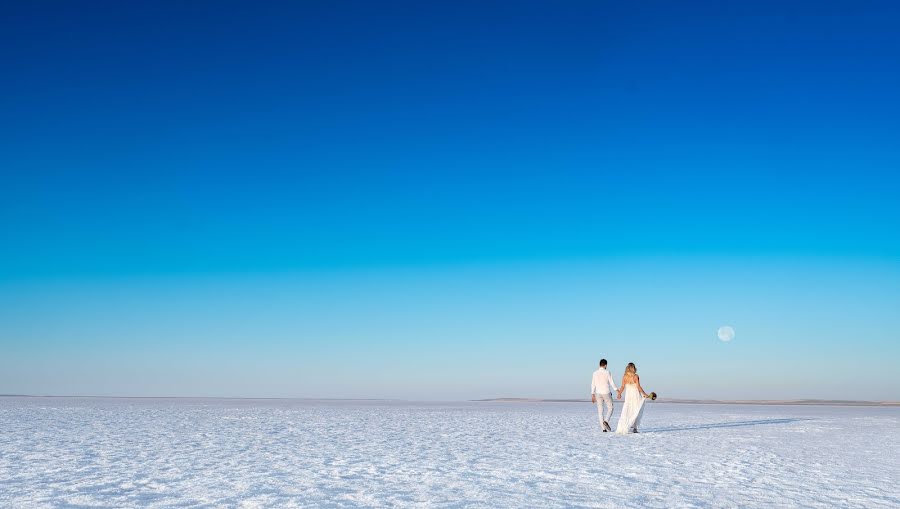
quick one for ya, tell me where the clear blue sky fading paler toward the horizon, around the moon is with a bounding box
[0,1,900,400]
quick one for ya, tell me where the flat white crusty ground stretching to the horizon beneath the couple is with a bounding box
[0,398,900,508]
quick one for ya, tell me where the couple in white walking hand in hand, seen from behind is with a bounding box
[591,359,655,435]
